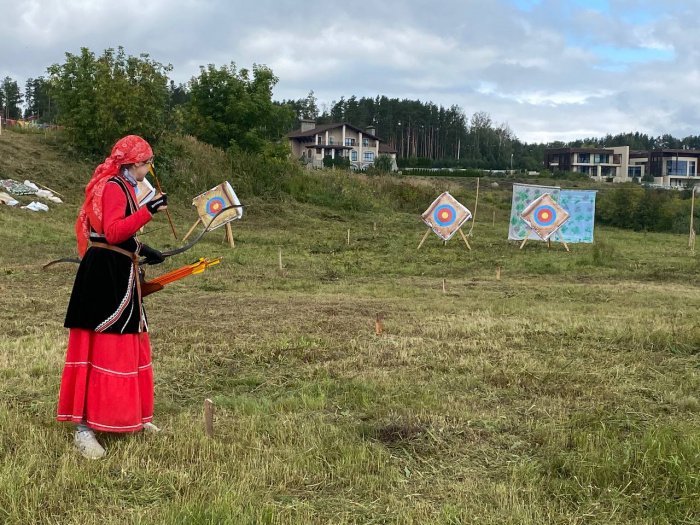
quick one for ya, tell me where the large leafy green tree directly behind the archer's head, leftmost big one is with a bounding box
[48,47,172,153]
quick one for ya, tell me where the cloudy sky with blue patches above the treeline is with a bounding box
[0,0,700,142]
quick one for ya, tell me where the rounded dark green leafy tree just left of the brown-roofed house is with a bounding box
[185,63,294,156]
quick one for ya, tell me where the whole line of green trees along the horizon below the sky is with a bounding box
[6,48,700,171]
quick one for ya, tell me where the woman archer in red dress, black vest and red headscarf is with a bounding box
[57,135,167,459]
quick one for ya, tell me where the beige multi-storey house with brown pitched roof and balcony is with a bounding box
[287,120,397,170]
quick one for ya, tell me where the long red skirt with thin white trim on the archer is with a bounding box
[56,328,153,432]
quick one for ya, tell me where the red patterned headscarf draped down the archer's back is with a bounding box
[75,135,153,257]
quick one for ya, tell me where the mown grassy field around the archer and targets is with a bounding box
[0,129,700,525]
